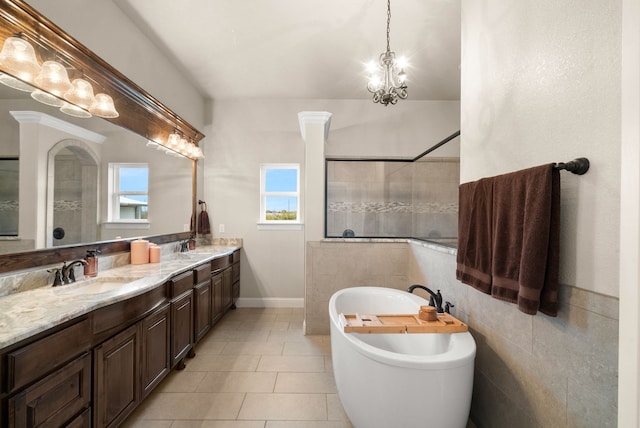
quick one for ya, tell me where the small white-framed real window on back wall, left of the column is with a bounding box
[260,164,301,224]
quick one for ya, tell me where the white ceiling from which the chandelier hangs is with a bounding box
[114,0,460,100]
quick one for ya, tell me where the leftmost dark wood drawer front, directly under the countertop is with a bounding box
[6,318,91,393]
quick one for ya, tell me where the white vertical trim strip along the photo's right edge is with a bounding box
[618,0,640,427]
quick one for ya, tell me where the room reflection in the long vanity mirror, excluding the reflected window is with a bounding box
[0,85,192,253]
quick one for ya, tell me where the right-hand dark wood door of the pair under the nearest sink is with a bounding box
[140,303,171,399]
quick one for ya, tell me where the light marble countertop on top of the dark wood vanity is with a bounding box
[0,246,239,349]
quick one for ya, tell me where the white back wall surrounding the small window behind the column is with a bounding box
[203,99,459,304]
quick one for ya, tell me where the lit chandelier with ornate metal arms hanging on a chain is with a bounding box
[367,0,408,106]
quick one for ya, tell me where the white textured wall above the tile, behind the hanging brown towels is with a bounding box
[460,0,621,296]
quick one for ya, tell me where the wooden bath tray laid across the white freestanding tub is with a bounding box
[340,313,469,334]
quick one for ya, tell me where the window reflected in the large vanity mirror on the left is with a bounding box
[109,163,149,222]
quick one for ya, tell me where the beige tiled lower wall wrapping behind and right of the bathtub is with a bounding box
[305,241,618,428]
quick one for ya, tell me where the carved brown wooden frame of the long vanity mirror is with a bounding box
[0,0,204,274]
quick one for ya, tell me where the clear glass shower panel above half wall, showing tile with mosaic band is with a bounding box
[325,133,460,246]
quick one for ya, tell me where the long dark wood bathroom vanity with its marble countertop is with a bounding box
[0,247,240,427]
